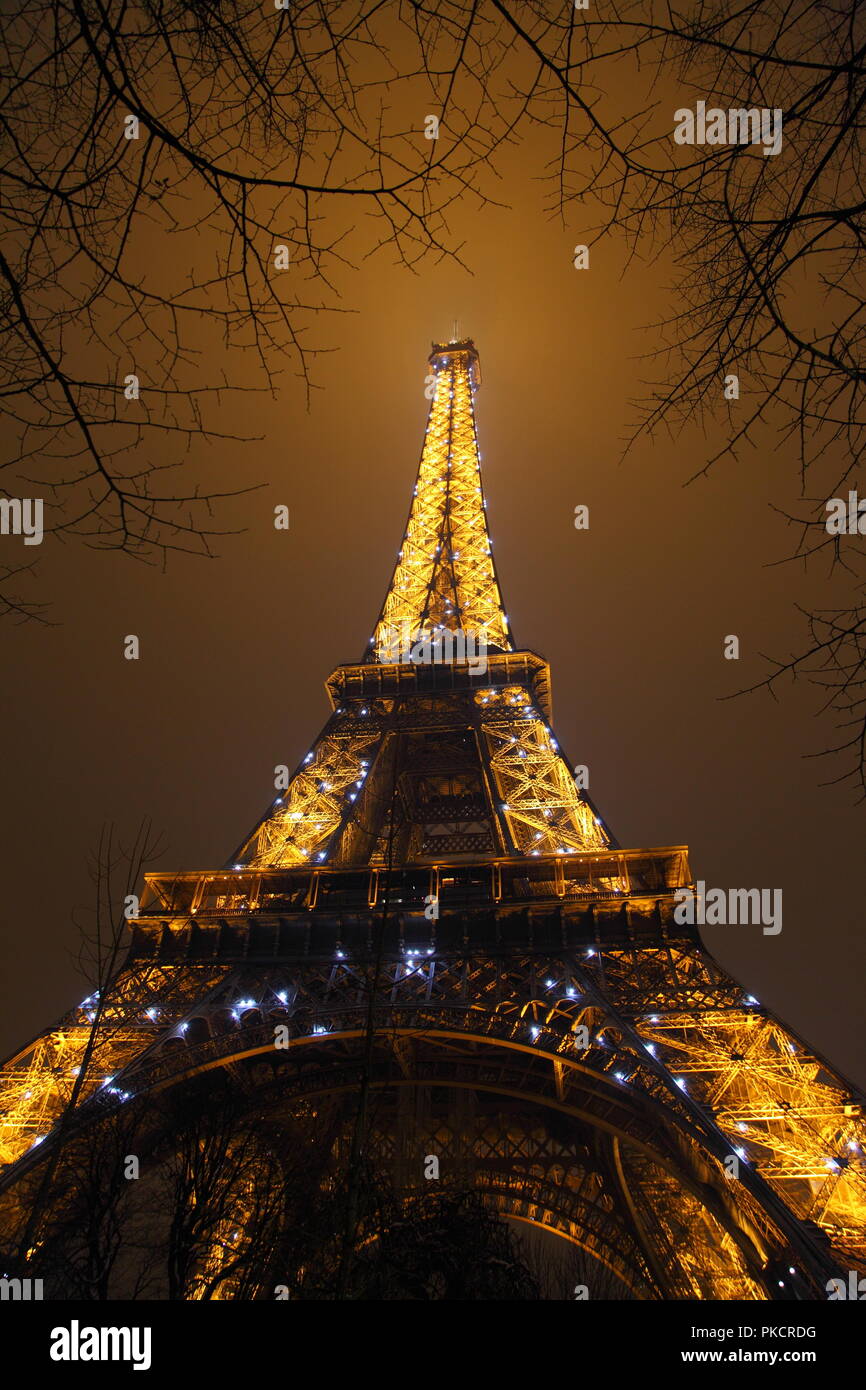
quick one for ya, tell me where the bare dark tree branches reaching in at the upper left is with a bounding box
[0,0,489,617]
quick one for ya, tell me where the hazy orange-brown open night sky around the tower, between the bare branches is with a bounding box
[0,100,866,1084]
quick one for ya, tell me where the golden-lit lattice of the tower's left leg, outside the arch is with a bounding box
[0,966,222,1166]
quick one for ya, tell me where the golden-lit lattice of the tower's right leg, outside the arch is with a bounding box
[575,947,866,1262]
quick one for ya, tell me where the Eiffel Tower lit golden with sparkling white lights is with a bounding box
[0,339,866,1300]
